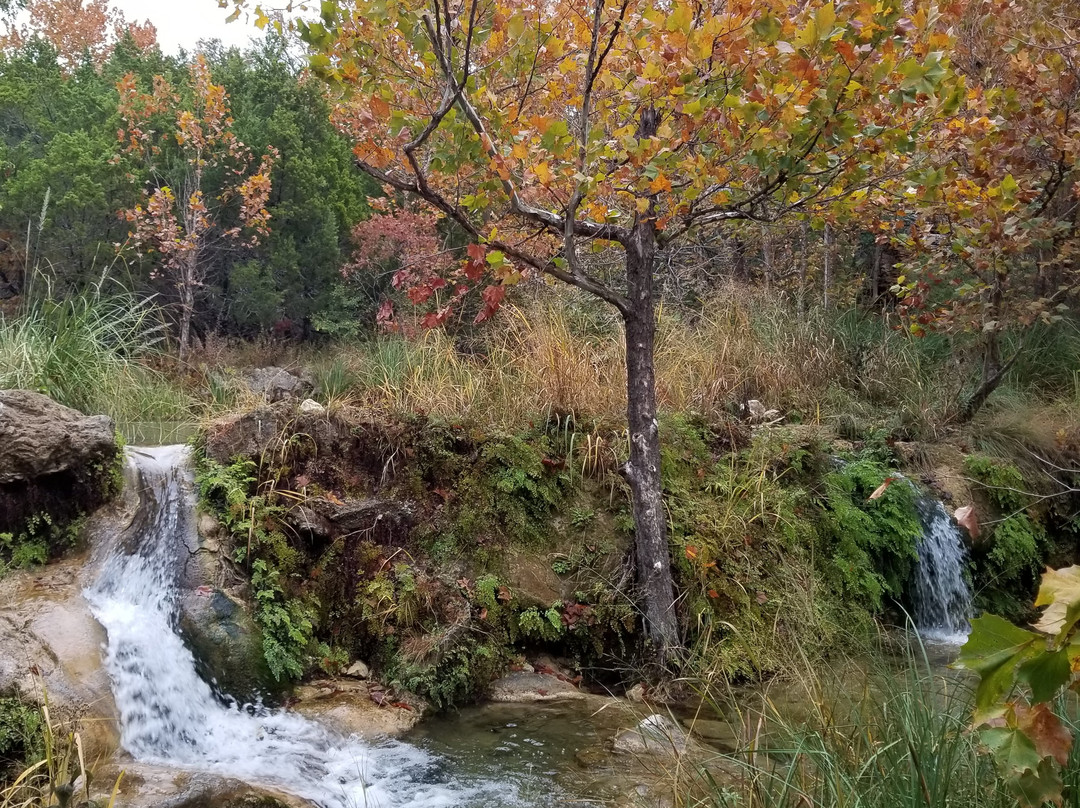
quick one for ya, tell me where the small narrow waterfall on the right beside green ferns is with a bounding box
[914,497,971,645]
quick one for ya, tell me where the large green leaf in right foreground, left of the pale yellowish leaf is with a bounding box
[956,615,1040,722]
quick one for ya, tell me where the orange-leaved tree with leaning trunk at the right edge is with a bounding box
[895,0,1080,420]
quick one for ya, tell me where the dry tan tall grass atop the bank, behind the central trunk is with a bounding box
[302,286,958,432]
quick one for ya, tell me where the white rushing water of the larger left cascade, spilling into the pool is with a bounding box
[85,446,521,808]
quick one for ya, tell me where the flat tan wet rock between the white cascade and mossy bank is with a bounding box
[293,679,426,740]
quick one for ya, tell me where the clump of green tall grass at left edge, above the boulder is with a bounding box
[0,274,192,422]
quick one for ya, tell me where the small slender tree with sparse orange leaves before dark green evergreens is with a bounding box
[118,56,278,360]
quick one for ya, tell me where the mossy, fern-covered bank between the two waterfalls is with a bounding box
[199,404,1080,706]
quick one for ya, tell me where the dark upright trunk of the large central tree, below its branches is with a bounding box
[624,211,678,664]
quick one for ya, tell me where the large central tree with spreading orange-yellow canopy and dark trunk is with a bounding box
[240,0,962,661]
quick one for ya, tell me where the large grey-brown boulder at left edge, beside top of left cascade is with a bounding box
[0,390,120,540]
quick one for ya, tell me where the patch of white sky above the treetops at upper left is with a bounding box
[109,0,261,54]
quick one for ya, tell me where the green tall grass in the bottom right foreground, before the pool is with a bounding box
[679,648,1036,808]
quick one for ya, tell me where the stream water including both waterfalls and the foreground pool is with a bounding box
[78,446,970,808]
